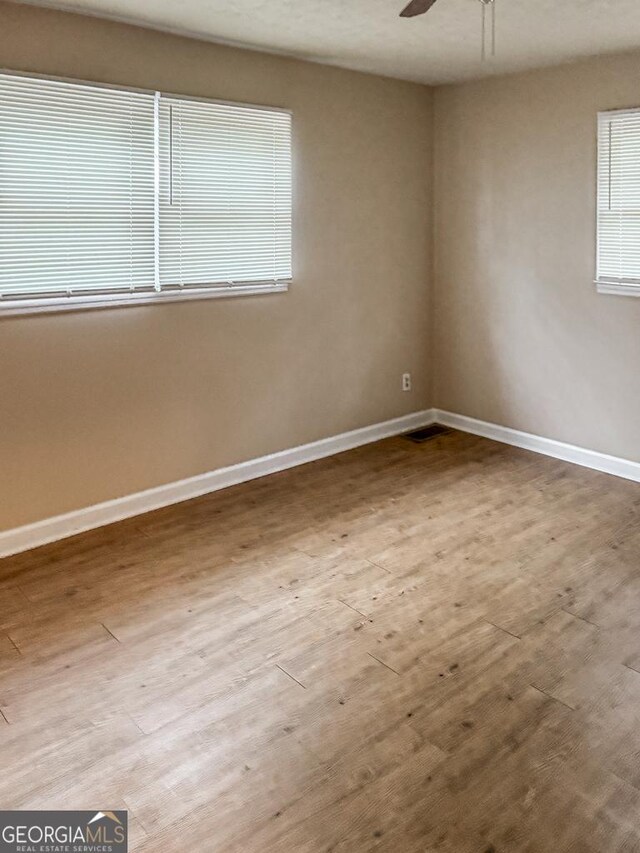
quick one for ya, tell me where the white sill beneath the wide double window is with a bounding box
[0,282,289,319]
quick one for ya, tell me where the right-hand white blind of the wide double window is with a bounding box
[160,93,291,287]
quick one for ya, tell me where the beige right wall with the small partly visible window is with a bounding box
[432,55,640,460]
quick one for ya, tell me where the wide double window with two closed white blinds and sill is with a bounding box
[0,74,291,312]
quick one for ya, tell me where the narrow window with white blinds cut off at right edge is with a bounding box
[596,110,640,296]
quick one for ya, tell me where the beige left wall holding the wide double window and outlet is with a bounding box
[0,3,432,529]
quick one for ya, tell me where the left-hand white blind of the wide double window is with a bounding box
[0,75,154,298]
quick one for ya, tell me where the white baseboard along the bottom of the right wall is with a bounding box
[434,409,640,483]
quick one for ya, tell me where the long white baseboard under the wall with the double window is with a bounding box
[0,409,434,557]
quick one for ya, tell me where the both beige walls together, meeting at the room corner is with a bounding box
[0,0,640,529]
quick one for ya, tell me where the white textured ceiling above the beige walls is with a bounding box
[15,0,640,83]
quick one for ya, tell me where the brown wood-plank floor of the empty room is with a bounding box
[0,433,640,853]
